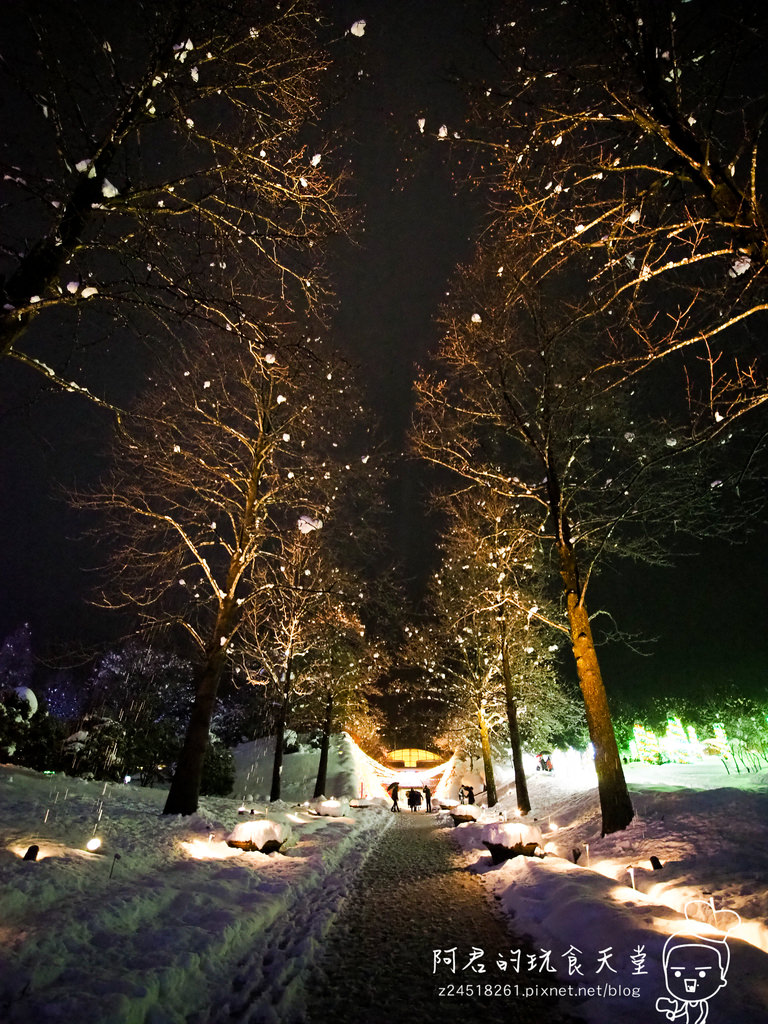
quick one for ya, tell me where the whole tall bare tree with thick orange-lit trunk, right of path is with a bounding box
[414,218,749,833]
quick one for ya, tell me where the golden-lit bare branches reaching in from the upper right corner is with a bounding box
[456,0,768,423]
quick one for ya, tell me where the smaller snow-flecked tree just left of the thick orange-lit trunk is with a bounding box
[409,487,574,814]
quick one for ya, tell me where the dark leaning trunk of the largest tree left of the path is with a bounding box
[163,644,224,814]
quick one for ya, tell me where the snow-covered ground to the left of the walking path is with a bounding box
[0,735,391,1024]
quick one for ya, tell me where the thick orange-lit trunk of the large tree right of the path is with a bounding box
[557,542,635,836]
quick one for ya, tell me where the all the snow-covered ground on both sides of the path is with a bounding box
[0,736,768,1024]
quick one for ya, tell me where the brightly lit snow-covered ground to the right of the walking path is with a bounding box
[453,756,768,1024]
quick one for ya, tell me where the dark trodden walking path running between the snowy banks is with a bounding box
[307,812,575,1024]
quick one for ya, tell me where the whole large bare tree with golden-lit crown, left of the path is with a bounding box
[74,329,373,814]
